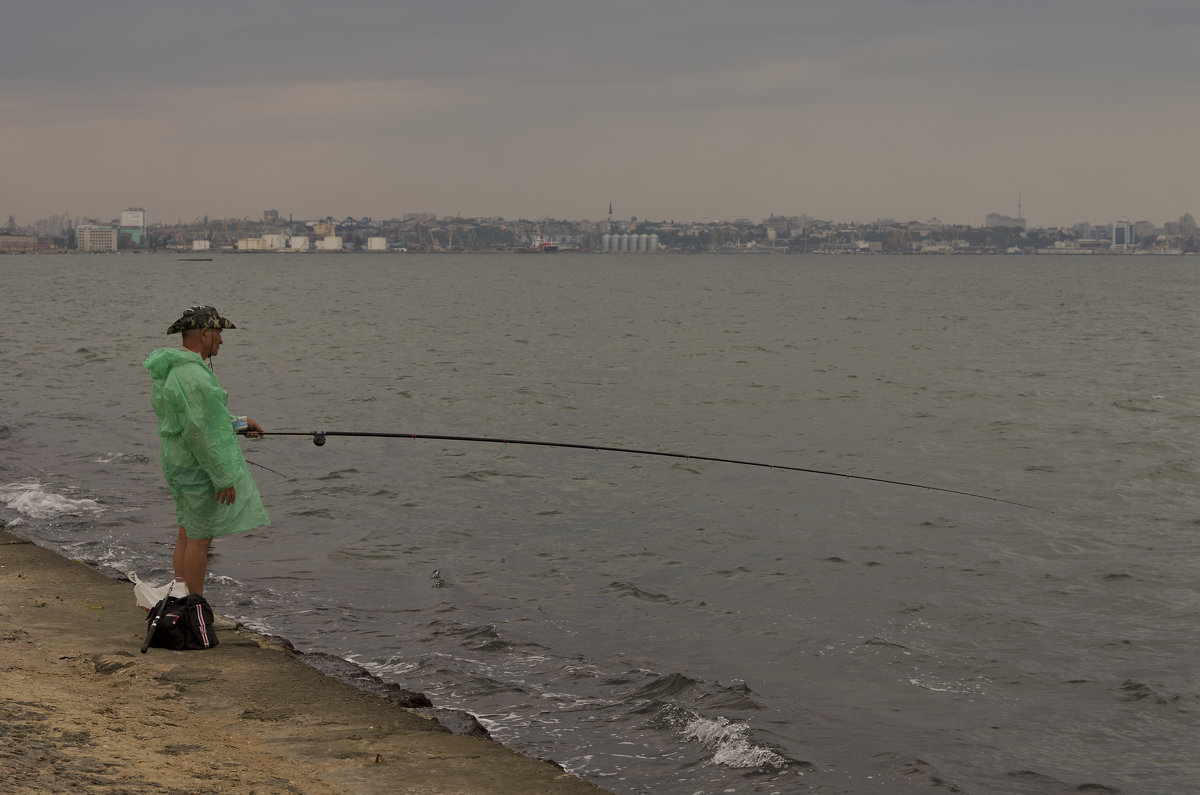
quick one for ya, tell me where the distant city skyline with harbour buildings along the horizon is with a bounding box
[9,202,1200,255]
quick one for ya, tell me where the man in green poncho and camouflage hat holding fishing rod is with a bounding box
[143,306,271,594]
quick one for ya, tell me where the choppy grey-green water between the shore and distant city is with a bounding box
[0,255,1200,794]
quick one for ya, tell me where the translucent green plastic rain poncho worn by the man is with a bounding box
[143,348,271,538]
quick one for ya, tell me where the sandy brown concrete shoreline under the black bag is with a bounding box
[0,528,605,795]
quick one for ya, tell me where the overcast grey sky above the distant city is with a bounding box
[0,0,1200,226]
